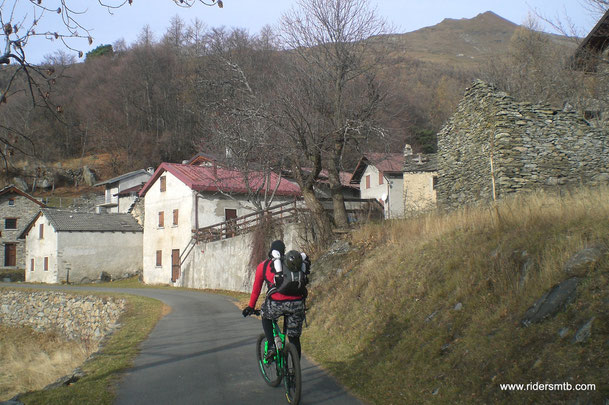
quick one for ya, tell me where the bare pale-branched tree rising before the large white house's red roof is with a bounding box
[195,28,286,210]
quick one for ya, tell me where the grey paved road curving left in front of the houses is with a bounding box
[0,283,362,405]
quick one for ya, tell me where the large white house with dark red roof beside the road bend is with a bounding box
[140,163,300,285]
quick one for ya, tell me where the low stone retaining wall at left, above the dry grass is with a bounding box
[0,289,126,342]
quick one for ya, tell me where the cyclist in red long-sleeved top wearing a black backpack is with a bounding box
[242,240,309,358]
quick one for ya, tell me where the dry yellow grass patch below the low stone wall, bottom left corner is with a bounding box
[0,325,94,401]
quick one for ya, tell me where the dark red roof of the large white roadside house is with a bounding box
[139,163,301,196]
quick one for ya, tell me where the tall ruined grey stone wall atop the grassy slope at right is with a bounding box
[437,81,609,208]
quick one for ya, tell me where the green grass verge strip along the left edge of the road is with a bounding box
[19,294,164,405]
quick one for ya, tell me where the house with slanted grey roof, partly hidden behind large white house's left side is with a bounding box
[95,168,154,213]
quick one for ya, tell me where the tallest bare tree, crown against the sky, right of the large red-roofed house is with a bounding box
[281,0,387,228]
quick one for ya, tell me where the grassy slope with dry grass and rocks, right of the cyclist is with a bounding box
[303,189,609,404]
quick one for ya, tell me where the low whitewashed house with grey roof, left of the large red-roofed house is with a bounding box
[21,208,143,284]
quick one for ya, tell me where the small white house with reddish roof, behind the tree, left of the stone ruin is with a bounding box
[351,153,404,219]
